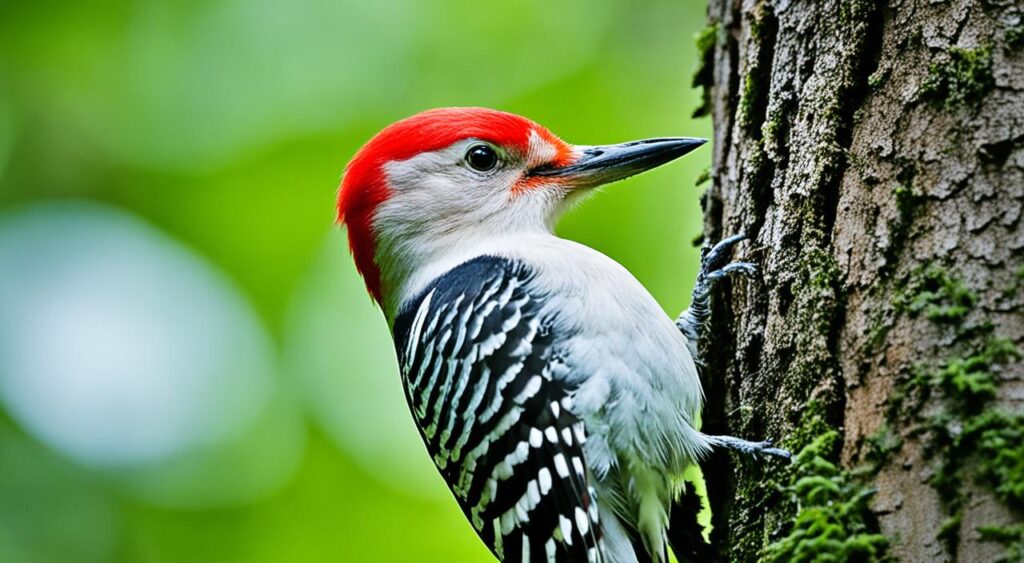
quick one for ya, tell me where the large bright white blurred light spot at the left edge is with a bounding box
[0,204,272,468]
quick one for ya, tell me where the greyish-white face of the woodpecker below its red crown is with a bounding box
[374,133,569,294]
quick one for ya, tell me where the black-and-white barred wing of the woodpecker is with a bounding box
[394,258,606,563]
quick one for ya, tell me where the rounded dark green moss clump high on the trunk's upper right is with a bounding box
[921,45,995,110]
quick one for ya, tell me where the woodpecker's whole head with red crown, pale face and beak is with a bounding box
[338,107,705,311]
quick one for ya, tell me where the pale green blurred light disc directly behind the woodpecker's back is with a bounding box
[285,230,451,502]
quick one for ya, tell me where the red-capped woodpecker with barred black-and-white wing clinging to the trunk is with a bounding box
[337,107,788,563]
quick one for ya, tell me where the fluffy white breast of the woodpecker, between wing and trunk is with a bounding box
[499,239,702,461]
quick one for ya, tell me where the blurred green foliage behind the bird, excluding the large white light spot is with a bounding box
[0,0,711,563]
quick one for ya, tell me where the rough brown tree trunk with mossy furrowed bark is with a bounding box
[696,0,1024,561]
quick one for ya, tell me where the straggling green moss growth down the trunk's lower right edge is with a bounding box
[868,265,1024,560]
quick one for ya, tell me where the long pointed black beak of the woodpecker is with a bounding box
[530,137,708,187]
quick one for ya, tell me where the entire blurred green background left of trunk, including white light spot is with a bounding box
[0,0,711,563]
